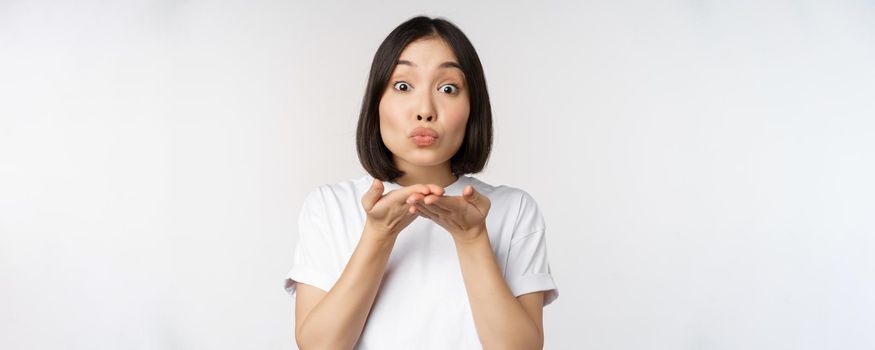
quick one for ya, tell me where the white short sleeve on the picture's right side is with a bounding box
[505,194,559,306]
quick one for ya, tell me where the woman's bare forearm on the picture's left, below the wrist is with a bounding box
[296,227,395,349]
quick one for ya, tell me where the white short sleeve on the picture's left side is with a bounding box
[285,189,337,296]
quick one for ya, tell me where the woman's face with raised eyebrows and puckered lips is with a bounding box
[380,37,471,169]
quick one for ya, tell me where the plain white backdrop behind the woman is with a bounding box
[0,0,875,350]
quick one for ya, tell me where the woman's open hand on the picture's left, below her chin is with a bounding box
[362,179,444,238]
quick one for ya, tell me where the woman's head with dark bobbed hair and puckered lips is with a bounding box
[356,17,492,181]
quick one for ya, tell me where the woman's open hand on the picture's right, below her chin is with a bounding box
[407,185,492,242]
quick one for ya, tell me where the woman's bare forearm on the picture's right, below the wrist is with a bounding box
[456,228,544,349]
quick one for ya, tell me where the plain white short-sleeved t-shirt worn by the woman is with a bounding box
[285,175,559,349]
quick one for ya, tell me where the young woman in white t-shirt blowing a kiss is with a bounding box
[285,16,558,349]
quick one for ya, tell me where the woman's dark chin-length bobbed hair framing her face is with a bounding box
[356,16,492,181]
